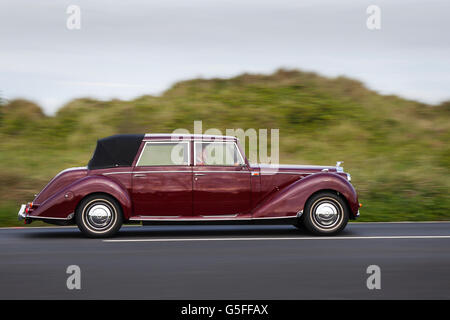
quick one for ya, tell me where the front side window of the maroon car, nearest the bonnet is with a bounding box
[194,142,244,166]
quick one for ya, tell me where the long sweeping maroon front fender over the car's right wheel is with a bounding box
[252,172,359,218]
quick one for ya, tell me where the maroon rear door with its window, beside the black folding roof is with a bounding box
[132,141,192,218]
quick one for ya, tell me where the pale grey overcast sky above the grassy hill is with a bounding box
[0,0,450,114]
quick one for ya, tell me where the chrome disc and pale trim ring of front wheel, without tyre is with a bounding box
[311,197,344,231]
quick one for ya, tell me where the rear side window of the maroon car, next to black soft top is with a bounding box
[137,142,189,167]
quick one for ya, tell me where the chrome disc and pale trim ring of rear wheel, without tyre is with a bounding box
[82,199,117,233]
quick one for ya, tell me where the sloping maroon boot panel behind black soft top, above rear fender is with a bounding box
[33,167,88,204]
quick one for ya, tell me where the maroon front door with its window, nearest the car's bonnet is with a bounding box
[193,141,251,218]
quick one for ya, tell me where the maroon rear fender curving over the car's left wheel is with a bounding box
[29,175,132,219]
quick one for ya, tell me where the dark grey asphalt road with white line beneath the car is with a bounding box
[0,222,450,299]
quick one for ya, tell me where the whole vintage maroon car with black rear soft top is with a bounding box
[19,134,360,237]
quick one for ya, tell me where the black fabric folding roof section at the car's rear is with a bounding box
[88,134,145,170]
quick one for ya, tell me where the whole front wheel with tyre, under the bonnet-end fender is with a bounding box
[302,192,349,236]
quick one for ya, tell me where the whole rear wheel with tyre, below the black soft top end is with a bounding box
[75,195,122,238]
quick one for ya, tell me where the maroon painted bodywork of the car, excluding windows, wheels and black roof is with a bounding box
[26,135,359,223]
